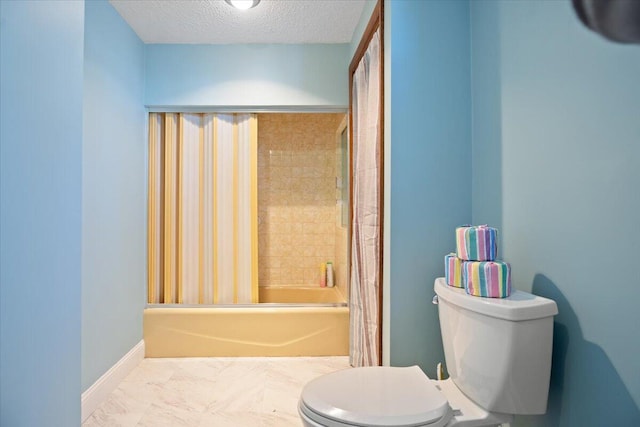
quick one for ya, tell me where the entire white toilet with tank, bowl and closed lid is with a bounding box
[298,278,558,427]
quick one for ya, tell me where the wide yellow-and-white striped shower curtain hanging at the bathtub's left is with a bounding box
[148,113,258,304]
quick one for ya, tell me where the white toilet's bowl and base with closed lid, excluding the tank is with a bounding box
[298,366,513,427]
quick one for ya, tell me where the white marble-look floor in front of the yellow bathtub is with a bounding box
[82,357,349,427]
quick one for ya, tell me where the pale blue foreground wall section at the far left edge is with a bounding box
[0,1,84,427]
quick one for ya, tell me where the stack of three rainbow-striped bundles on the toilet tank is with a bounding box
[444,225,511,298]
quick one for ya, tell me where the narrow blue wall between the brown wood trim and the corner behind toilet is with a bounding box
[385,0,471,375]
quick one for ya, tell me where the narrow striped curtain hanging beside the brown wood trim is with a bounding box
[349,30,382,366]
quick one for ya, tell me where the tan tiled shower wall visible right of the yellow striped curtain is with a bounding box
[258,113,344,287]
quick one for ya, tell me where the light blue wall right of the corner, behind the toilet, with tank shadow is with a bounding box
[471,1,640,426]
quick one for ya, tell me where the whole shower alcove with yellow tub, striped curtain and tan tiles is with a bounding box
[144,112,349,357]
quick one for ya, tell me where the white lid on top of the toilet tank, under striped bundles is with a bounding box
[433,277,558,321]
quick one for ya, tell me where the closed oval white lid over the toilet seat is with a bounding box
[301,366,451,427]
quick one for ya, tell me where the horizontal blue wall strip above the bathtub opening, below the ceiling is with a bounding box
[145,44,349,108]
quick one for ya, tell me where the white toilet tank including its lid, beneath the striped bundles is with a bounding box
[434,278,558,414]
